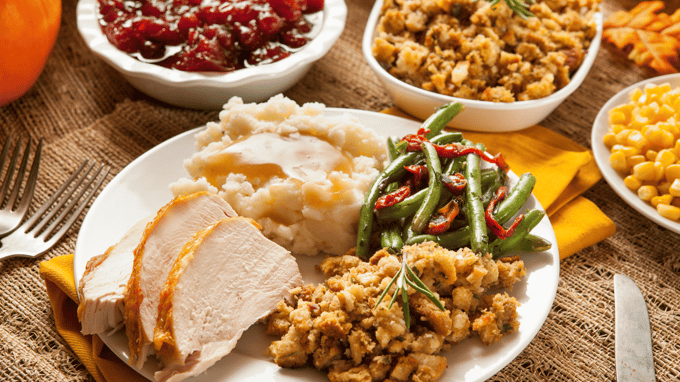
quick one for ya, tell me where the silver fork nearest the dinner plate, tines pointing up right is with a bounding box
[0,160,109,260]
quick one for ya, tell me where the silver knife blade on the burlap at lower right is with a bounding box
[614,275,656,382]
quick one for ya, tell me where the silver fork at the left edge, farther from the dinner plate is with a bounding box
[0,133,43,236]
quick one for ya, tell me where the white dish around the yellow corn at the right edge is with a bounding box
[591,73,680,233]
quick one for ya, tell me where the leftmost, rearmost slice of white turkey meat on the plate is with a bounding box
[78,215,153,334]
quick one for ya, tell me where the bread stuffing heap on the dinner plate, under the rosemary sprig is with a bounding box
[267,242,526,381]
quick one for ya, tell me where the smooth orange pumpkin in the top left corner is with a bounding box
[0,0,61,106]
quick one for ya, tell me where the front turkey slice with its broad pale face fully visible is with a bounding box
[154,217,302,382]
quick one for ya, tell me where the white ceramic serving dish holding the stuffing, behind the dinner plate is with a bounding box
[362,0,602,132]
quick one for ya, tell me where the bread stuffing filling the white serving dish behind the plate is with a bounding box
[373,0,601,102]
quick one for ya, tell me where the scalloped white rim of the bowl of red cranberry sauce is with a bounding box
[76,0,347,88]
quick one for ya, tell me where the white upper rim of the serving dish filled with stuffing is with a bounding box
[362,0,603,110]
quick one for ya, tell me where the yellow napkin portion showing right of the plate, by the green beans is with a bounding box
[383,108,616,259]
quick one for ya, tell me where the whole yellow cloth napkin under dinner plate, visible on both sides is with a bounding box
[40,109,615,382]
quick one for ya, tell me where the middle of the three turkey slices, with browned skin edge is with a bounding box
[124,192,236,368]
